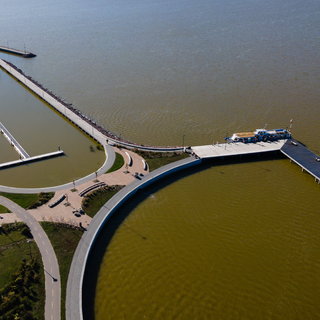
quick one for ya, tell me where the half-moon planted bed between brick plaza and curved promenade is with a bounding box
[81,186,123,217]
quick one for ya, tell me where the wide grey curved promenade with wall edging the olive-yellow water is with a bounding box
[66,157,202,320]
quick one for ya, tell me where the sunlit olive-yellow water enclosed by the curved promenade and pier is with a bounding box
[96,160,320,319]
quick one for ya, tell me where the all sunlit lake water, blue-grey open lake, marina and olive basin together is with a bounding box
[0,0,320,319]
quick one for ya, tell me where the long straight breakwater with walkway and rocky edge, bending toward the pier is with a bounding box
[0,59,183,152]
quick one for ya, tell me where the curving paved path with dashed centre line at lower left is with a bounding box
[0,196,61,320]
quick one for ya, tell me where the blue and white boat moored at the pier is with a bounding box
[225,129,291,143]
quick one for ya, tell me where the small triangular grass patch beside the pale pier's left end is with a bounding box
[135,150,189,171]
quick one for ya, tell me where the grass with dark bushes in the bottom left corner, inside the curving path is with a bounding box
[0,223,45,320]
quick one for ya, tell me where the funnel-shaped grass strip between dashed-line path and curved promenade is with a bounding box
[41,222,83,319]
